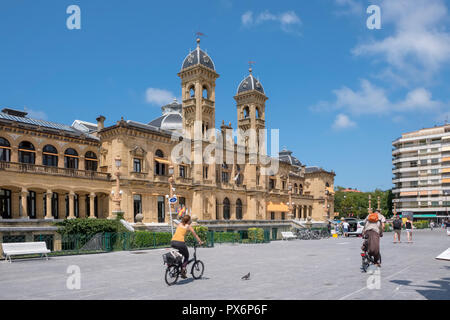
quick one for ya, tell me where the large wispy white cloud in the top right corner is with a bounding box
[352,0,450,82]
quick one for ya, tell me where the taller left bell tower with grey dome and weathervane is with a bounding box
[178,39,219,140]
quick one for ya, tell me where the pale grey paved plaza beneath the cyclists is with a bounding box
[0,230,450,300]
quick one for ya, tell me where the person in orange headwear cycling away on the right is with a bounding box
[362,210,386,267]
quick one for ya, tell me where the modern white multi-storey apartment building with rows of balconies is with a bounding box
[392,124,450,218]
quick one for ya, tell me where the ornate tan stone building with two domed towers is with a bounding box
[0,41,335,223]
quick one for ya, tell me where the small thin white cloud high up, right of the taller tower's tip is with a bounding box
[241,10,301,32]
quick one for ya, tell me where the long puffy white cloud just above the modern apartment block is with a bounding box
[311,79,446,116]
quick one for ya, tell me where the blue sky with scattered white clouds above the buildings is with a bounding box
[0,0,450,190]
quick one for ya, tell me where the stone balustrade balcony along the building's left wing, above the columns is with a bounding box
[0,161,111,180]
